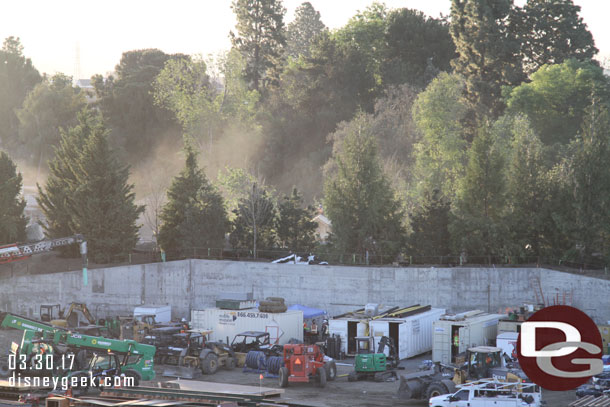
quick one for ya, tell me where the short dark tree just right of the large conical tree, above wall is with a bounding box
[408,189,451,256]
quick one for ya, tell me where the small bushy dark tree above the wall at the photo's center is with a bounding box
[276,188,317,252]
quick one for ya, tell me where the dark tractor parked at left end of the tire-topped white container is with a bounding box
[163,330,236,379]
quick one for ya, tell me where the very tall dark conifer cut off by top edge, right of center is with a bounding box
[450,0,522,121]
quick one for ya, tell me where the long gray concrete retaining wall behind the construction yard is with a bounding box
[0,260,610,323]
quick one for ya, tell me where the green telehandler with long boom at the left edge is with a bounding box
[0,313,156,380]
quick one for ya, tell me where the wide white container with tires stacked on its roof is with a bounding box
[191,308,303,345]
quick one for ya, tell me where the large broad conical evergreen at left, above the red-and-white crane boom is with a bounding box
[39,110,144,262]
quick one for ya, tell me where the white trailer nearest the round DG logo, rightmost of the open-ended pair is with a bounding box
[432,310,506,364]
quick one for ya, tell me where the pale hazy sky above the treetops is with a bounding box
[0,0,610,78]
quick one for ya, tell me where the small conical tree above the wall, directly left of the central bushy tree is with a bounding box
[231,182,276,259]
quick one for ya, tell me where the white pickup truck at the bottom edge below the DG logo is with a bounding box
[428,379,542,407]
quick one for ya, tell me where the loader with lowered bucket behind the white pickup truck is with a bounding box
[398,346,527,399]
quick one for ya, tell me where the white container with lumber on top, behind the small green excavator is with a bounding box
[369,308,445,359]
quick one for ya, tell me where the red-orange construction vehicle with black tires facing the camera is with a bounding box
[279,344,337,387]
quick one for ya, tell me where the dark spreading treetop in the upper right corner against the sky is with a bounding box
[513,0,597,76]
